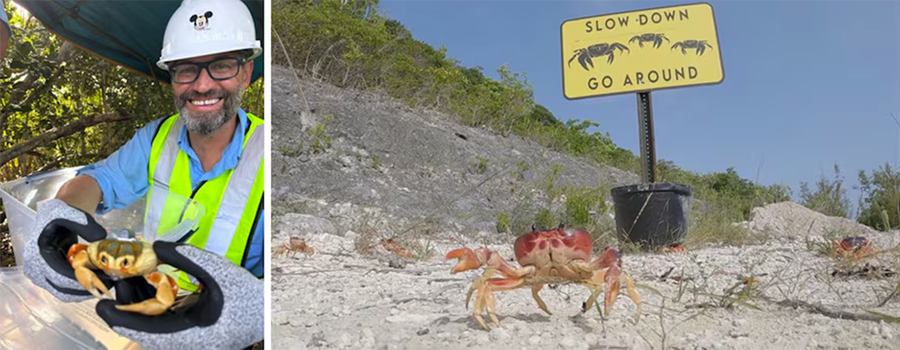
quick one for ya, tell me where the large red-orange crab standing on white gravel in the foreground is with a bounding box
[446,225,641,330]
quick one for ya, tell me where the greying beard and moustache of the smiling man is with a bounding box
[175,86,244,135]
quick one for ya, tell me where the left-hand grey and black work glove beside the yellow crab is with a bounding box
[23,199,113,302]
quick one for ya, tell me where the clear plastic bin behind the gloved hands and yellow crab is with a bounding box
[0,167,206,266]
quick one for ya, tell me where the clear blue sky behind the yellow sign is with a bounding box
[379,0,900,216]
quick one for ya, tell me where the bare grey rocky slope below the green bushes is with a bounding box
[270,66,639,246]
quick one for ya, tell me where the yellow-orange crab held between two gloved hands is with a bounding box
[67,239,178,316]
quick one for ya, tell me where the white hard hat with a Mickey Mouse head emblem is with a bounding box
[156,0,262,70]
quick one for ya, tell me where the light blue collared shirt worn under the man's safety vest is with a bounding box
[79,109,265,277]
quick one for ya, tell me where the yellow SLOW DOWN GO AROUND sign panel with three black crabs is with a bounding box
[560,3,725,100]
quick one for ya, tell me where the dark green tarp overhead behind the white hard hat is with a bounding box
[13,0,265,84]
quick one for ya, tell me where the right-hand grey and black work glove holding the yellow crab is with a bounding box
[97,241,265,350]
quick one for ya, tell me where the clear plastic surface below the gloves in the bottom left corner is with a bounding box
[0,267,141,350]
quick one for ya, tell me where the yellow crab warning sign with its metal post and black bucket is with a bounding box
[560,3,725,250]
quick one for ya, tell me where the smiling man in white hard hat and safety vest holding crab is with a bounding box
[25,0,265,349]
